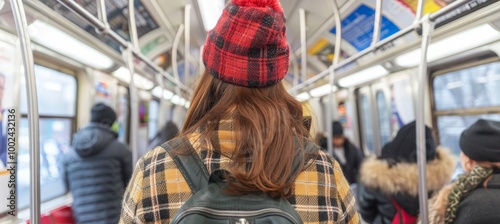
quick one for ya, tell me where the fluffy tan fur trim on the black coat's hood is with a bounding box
[360,147,456,197]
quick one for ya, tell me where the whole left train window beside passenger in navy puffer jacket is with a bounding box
[17,65,77,209]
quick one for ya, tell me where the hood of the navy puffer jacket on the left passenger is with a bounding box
[72,123,118,157]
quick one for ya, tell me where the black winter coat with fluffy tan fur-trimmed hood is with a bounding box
[358,147,456,224]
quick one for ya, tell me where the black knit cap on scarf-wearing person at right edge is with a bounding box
[460,119,500,162]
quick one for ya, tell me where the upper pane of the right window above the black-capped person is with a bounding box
[433,61,500,110]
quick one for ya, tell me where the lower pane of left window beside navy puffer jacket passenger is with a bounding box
[17,118,71,209]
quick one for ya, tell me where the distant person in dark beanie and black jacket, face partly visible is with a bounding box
[332,121,363,184]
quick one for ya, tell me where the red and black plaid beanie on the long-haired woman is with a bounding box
[203,0,290,87]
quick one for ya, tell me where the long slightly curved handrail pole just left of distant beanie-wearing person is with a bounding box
[326,0,342,158]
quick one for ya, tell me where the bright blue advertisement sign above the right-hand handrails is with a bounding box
[330,4,399,51]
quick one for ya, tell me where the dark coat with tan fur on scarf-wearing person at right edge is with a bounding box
[429,169,500,224]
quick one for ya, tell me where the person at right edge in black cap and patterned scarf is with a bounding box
[429,119,500,224]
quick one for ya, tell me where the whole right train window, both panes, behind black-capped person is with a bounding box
[432,60,500,178]
